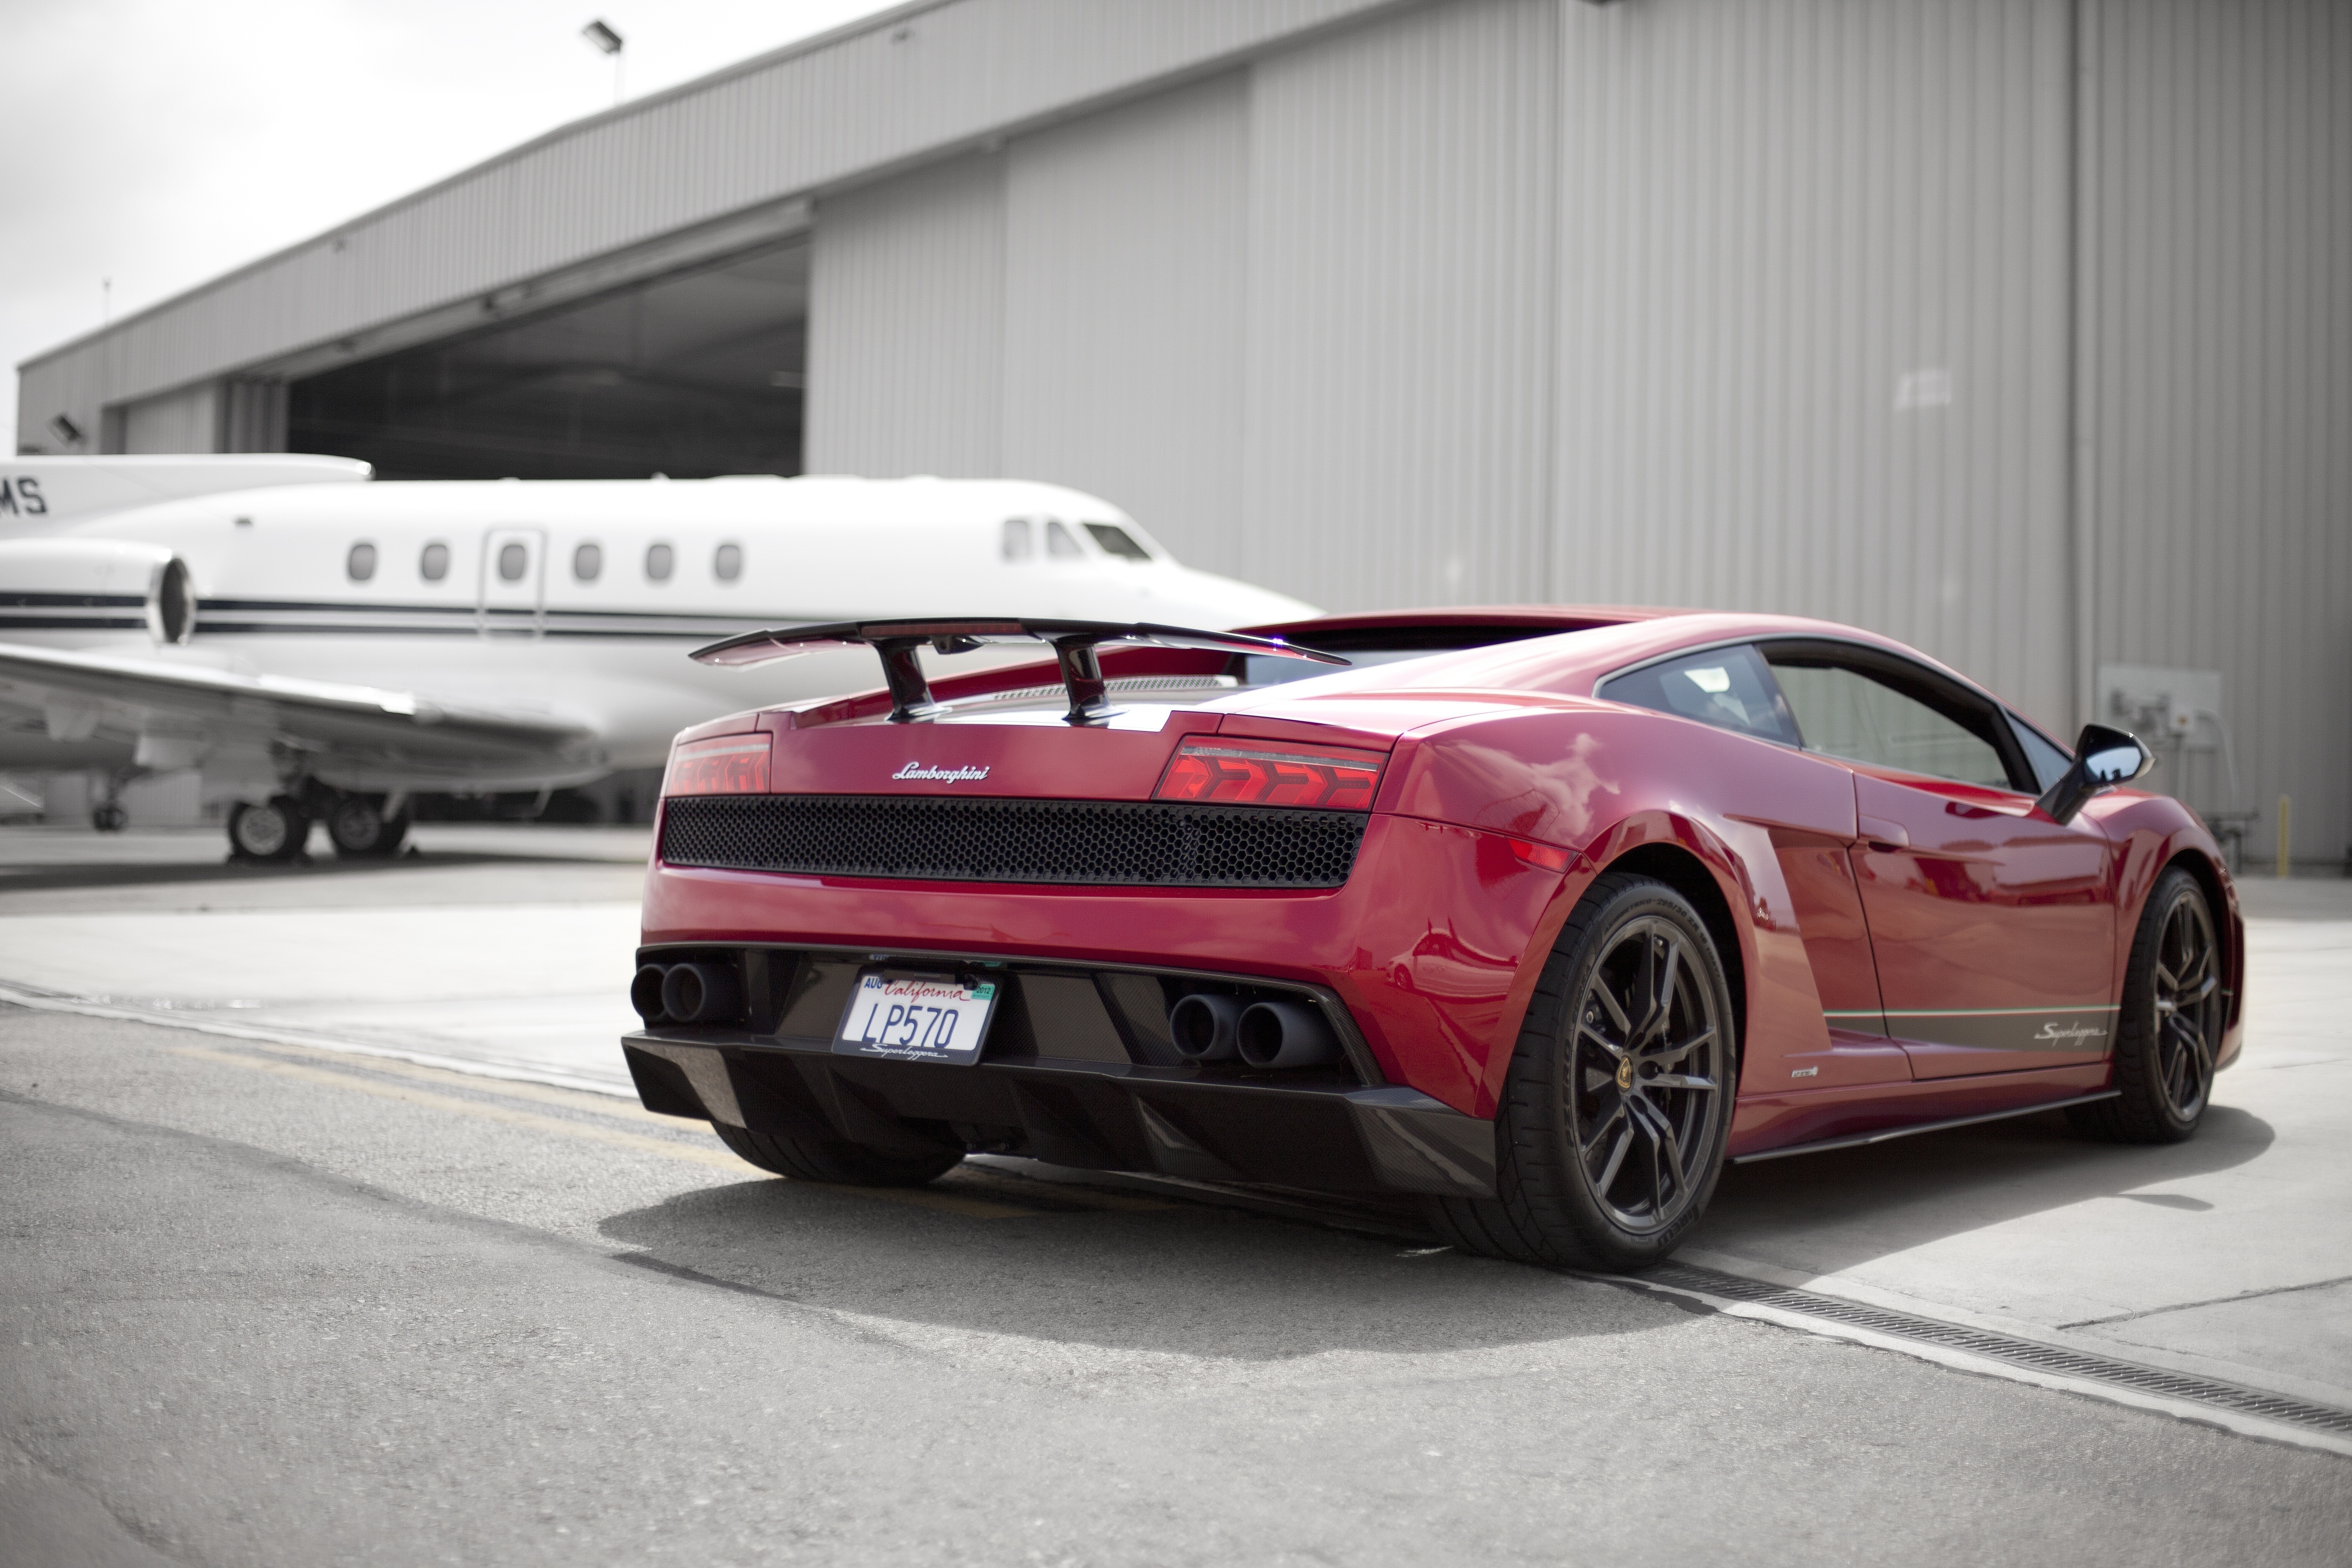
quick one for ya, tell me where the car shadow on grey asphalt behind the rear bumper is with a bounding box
[602,1173,1687,1361]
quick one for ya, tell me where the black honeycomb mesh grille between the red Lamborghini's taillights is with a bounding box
[661,794,1364,889]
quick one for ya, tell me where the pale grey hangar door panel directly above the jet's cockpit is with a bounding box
[1004,75,1249,571]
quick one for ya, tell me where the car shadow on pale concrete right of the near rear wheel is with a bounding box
[1689,1105,2277,1274]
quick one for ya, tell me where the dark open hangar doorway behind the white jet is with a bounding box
[287,242,809,480]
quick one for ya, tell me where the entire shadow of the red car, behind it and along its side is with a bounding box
[600,1107,2272,1361]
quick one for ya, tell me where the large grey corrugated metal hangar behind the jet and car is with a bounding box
[19,0,2352,865]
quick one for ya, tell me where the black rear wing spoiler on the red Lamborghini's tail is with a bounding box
[694,616,1348,724]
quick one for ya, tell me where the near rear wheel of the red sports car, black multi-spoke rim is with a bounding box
[1430,872,1738,1272]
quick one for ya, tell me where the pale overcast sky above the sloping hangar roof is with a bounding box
[0,0,887,451]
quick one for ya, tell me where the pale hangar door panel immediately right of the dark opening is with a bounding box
[805,153,1004,477]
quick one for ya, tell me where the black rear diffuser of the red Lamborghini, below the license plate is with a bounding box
[621,1030,1496,1197]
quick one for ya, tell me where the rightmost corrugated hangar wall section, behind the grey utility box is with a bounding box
[2084,0,2352,860]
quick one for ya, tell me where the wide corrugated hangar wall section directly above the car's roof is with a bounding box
[1550,0,2072,729]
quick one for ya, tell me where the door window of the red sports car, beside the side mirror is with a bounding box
[1764,644,2016,790]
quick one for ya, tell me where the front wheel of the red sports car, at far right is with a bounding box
[2067,865,2227,1142]
